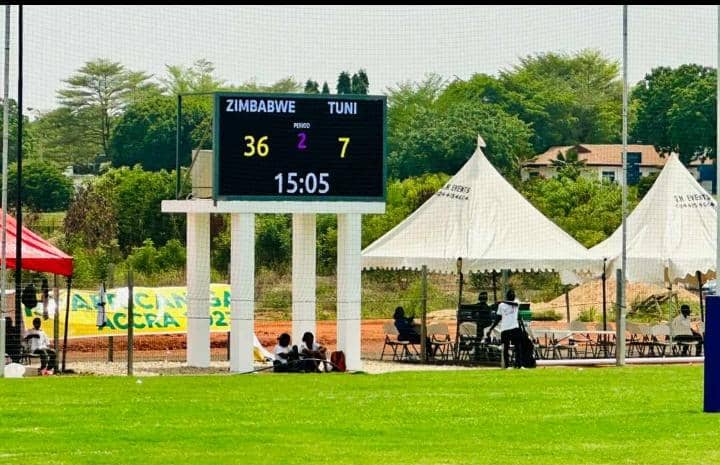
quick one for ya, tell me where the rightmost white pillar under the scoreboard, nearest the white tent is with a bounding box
[337,213,362,370]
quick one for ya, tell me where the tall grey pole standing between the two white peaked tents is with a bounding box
[615,5,628,366]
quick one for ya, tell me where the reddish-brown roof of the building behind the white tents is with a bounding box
[523,144,667,168]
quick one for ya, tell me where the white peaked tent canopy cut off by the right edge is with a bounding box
[590,155,716,283]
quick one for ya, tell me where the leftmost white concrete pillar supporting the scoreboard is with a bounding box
[187,213,210,368]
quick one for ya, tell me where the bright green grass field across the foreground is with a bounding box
[0,366,720,465]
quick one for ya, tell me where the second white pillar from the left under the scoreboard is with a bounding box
[230,213,255,373]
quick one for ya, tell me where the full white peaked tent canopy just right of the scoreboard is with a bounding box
[362,138,602,279]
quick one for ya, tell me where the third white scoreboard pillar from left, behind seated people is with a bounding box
[292,213,317,345]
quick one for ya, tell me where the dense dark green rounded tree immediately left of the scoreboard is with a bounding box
[110,95,212,171]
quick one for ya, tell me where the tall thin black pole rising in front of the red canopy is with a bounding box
[15,5,22,337]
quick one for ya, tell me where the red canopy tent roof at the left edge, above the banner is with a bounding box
[0,210,73,276]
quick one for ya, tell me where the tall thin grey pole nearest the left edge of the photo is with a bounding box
[0,5,10,378]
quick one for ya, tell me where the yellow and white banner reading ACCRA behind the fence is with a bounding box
[24,284,230,337]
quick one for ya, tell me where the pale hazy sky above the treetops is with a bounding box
[0,5,718,111]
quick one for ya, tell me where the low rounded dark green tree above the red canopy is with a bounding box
[8,158,73,212]
